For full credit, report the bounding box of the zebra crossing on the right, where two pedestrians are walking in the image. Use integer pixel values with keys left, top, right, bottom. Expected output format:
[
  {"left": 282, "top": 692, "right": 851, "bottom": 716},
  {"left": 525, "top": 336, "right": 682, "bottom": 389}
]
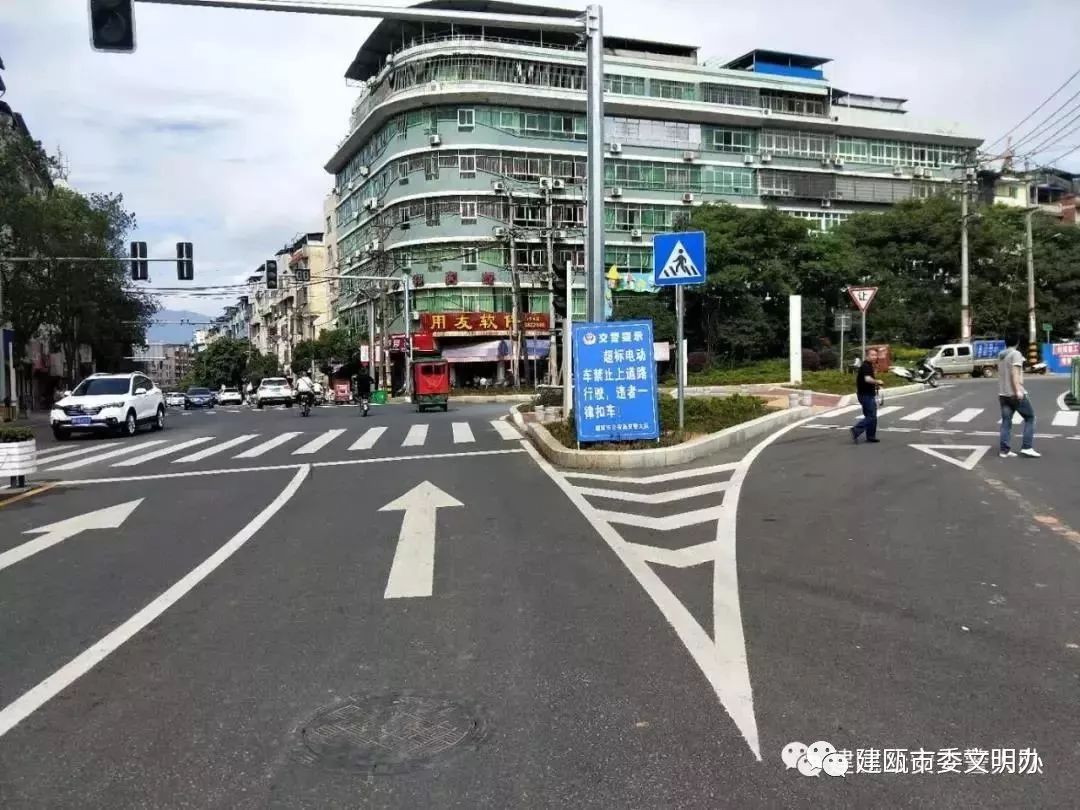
[{"left": 802, "top": 405, "right": 1080, "bottom": 442}]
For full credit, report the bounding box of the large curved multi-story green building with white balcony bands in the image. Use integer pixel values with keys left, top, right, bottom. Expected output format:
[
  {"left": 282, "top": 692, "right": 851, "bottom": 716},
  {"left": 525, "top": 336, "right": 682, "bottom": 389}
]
[{"left": 326, "top": 0, "right": 981, "bottom": 386}]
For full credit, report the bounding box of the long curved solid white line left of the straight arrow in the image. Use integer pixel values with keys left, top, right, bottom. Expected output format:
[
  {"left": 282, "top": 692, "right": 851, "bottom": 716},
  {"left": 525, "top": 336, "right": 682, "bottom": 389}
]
[{"left": 0, "top": 465, "right": 311, "bottom": 737}]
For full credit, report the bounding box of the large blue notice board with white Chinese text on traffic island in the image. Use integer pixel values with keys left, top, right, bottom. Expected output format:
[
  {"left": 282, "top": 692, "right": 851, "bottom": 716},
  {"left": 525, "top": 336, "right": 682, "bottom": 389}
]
[{"left": 573, "top": 321, "right": 660, "bottom": 442}]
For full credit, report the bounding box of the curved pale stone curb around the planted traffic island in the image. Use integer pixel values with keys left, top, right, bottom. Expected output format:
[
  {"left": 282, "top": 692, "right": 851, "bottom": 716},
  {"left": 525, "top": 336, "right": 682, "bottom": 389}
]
[{"left": 511, "top": 406, "right": 813, "bottom": 470}]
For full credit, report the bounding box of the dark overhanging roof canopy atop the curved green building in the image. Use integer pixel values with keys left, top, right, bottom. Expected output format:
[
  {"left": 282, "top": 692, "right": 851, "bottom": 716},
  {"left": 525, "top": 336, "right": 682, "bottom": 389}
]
[{"left": 345, "top": 0, "right": 698, "bottom": 81}]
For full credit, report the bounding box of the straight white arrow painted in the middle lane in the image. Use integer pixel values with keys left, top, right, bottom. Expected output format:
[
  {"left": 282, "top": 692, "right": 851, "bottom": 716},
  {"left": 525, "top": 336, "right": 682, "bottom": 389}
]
[{"left": 379, "top": 481, "right": 463, "bottom": 599}]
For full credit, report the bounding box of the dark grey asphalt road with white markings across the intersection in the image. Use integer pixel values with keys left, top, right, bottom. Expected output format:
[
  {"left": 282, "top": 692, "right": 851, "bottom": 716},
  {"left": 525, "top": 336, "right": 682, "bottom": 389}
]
[{"left": 0, "top": 380, "right": 1080, "bottom": 809}]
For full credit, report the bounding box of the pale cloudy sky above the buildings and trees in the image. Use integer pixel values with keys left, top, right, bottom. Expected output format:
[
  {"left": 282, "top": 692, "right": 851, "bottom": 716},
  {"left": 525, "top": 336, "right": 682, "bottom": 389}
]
[{"left": 0, "top": 0, "right": 1080, "bottom": 315}]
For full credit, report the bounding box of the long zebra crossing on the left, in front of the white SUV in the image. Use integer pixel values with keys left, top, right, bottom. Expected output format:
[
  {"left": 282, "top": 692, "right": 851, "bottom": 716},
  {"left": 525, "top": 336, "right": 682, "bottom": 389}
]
[{"left": 38, "top": 419, "right": 523, "bottom": 473}]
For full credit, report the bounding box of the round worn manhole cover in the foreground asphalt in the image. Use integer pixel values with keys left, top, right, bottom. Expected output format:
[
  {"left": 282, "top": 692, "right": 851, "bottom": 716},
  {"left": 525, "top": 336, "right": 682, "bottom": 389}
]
[{"left": 300, "top": 693, "right": 486, "bottom": 773}]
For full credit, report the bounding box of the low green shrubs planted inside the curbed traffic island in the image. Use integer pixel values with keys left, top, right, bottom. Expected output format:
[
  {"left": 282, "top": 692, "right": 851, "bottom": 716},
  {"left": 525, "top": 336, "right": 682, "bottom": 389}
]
[{"left": 543, "top": 394, "right": 773, "bottom": 450}]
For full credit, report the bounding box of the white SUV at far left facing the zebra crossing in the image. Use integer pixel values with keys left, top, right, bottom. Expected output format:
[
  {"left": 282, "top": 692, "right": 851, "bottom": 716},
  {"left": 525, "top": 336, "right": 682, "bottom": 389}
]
[{"left": 50, "top": 374, "right": 165, "bottom": 440}]
